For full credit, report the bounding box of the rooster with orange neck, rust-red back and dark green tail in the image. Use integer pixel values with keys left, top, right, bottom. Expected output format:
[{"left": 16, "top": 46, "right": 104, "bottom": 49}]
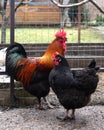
[{"left": 6, "top": 29, "right": 67, "bottom": 109}]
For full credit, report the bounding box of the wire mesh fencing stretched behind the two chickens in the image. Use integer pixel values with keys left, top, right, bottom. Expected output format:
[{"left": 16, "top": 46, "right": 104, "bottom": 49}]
[{"left": 0, "top": 0, "right": 104, "bottom": 105}]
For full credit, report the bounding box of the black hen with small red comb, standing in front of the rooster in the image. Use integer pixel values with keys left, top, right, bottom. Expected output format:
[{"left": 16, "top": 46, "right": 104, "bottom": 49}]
[{"left": 49, "top": 53, "right": 99, "bottom": 120}]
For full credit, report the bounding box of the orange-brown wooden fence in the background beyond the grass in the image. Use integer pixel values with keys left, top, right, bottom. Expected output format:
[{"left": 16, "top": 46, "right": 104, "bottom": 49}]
[{"left": 0, "top": 5, "right": 61, "bottom": 26}]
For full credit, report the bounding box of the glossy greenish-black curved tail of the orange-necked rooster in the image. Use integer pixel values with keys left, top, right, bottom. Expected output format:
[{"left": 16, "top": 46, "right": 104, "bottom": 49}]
[{"left": 5, "top": 43, "right": 27, "bottom": 79}]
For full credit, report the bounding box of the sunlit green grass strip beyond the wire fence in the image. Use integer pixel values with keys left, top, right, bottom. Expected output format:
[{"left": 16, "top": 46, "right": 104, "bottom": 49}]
[{"left": 0, "top": 27, "right": 104, "bottom": 43}]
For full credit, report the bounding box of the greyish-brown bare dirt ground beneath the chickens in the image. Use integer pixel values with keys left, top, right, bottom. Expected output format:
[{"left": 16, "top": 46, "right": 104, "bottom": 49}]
[{"left": 0, "top": 73, "right": 104, "bottom": 130}]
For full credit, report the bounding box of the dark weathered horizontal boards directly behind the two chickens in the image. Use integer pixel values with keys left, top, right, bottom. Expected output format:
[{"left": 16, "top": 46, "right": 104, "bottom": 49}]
[{"left": 0, "top": 43, "right": 104, "bottom": 68}]
